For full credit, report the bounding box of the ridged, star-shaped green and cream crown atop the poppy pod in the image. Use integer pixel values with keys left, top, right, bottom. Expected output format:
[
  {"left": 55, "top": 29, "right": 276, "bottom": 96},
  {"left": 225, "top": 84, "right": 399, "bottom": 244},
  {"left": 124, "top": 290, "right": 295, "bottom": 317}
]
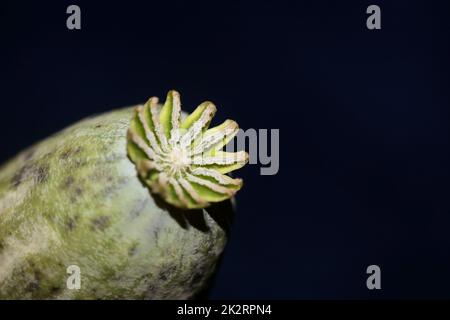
[{"left": 127, "top": 90, "right": 248, "bottom": 209}]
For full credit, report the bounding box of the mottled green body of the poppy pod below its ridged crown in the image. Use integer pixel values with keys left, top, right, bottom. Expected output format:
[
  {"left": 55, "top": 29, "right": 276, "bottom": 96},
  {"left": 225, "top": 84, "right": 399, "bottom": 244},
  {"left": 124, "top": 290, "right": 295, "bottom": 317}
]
[{"left": 0, "top": 107, "right": 233, "bottom": 299}]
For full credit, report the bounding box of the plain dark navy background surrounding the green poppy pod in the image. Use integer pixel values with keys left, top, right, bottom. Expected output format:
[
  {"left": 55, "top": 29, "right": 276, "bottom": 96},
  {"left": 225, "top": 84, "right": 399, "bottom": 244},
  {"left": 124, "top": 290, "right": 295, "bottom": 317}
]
[{"left": 0, "top": 0, "right": 450, "bottom": 298}]
